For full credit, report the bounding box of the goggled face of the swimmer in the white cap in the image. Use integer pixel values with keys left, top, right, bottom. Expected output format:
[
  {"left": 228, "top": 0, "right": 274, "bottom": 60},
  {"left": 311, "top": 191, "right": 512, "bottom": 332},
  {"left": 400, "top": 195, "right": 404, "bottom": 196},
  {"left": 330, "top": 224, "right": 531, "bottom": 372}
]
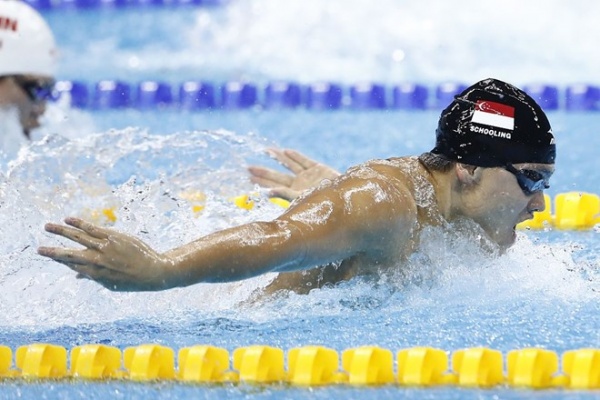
[{"left": 0, "top": 75, "right": 54, "bottom": 137}]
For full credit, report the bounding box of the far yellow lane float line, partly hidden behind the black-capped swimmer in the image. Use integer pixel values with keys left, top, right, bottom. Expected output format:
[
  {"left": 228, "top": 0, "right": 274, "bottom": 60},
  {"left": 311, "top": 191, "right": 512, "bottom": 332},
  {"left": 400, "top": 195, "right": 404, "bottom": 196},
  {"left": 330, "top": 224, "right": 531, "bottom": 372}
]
[{"left": 84, "top": 192, "right": 600, "bottom": 230}]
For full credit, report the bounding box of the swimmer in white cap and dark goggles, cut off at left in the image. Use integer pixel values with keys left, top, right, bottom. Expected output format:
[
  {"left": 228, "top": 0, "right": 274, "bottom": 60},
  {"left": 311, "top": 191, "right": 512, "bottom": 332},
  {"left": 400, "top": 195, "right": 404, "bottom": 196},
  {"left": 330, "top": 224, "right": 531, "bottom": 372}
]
[{"left": 0, "top": 0, "right": 57, "bottom": 139}]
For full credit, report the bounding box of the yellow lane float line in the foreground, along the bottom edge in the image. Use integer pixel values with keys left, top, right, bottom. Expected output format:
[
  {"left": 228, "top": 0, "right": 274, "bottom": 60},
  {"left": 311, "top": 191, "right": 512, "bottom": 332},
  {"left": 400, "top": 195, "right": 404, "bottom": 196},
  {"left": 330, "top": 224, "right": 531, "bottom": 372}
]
[{"left": 0, "top": 343, "right": 600, "bottom": 390}]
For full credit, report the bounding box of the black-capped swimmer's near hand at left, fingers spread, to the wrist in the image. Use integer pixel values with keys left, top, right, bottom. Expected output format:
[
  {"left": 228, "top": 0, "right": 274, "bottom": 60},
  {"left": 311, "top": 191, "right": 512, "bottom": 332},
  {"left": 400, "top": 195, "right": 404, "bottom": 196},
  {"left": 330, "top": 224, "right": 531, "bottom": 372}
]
[{"left": 38, "top": 218, "right": 173, "bottom": 291}]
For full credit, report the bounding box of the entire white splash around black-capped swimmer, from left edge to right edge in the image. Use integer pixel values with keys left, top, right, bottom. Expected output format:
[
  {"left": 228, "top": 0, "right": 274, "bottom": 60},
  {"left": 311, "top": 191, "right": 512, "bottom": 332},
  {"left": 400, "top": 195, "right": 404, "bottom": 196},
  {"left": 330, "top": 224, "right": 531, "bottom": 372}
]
[{"left": 0, "top": 128, "right": 599, "bottom": 329}]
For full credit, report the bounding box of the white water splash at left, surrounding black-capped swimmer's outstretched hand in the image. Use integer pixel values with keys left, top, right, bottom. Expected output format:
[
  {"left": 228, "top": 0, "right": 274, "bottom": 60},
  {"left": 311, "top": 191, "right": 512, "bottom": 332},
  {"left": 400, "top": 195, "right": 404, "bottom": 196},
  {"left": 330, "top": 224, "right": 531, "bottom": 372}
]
[{"left": 0, "top": 128, "right": 281, "bottom": 325}]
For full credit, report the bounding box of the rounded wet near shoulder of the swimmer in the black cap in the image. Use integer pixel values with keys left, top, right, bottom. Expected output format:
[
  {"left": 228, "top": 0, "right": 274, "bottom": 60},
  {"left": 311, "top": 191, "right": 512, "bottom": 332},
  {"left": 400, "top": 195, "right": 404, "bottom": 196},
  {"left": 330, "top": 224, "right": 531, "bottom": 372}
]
[{"left": 280, "top": 155, "right": 417, "bottom": 247}]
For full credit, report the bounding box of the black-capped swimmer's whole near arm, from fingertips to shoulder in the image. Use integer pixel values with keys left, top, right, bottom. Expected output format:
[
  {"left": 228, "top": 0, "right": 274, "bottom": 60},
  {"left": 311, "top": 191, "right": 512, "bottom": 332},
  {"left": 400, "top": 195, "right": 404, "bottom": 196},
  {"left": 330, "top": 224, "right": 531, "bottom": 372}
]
[{"left": 38, "top": 173, "right": 416, "bottom": 291}]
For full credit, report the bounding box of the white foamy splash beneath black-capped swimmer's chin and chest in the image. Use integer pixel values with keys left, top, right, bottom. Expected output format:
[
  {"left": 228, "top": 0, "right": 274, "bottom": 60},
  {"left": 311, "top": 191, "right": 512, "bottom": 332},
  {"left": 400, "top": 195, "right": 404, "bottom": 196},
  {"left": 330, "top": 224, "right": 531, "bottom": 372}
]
[{"left": 244, "top": 225, "right": 600, "bottom": 324}]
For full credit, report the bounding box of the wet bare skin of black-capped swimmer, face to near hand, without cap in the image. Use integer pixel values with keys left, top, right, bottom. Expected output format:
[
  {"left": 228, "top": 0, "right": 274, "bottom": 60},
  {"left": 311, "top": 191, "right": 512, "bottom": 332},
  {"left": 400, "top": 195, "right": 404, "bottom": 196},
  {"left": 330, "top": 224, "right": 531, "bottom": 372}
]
[{"left": 38, "top": 157, "right": 553, "bottom": 291}]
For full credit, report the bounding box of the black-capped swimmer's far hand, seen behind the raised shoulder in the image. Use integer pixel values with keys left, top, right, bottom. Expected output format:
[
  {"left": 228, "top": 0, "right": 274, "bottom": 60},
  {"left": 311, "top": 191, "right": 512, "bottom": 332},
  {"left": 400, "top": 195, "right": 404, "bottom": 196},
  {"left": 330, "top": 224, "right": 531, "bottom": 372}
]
[{"left": 248, "top": 149, "right": 340, "bottom": 200}]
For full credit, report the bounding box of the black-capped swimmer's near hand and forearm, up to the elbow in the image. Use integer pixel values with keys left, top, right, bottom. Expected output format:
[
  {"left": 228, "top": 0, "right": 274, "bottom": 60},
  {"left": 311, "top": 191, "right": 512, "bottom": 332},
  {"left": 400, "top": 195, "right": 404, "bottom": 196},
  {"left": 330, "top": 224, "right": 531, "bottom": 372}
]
[{"left": 38, "top": 218, "right": 310, "bottom": 291}]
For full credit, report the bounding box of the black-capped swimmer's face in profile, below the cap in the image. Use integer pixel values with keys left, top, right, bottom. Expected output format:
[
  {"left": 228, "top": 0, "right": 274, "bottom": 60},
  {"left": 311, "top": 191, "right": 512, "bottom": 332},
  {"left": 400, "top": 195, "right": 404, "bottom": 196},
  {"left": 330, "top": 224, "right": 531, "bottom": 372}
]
[{"left": 465, "top": 164, "right": 554, "bottom": 248}]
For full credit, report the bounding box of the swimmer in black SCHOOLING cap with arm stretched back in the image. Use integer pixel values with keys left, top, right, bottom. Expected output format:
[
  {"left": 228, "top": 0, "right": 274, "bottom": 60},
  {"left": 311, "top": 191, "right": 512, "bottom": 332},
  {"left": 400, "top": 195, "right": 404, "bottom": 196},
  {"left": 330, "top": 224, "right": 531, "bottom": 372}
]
[{"left": 38, "top": 79, "right": 556, "bottom": 293}]
